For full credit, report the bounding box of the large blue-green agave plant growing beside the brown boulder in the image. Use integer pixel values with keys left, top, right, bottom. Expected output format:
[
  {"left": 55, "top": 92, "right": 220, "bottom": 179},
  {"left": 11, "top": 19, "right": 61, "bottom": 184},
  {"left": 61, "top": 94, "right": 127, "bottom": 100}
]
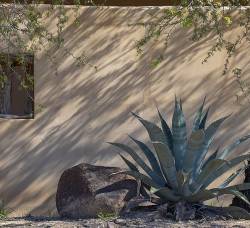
[{"left": 111, "top": 99, "right": 250, "bottom": 220}]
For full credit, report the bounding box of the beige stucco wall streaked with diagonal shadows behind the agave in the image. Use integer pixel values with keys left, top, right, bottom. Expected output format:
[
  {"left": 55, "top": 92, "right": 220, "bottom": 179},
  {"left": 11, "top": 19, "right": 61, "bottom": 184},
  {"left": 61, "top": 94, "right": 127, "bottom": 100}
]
[{"left": 0, "top": 7, "right": 250, "bottom": 215}]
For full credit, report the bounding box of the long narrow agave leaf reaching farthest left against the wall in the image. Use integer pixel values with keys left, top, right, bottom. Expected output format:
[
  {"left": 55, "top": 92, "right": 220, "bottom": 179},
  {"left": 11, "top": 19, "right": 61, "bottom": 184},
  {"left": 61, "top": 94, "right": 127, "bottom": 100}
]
[{"left": 110, "top": 143, "right": 165, "bottom": 184}]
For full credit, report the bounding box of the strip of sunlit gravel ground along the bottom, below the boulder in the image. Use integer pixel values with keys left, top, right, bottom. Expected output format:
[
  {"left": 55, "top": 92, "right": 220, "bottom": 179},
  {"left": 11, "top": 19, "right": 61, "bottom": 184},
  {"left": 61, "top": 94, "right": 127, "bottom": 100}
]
[{"left": 0, "top": 213, "right": 250, "bottom": 228}]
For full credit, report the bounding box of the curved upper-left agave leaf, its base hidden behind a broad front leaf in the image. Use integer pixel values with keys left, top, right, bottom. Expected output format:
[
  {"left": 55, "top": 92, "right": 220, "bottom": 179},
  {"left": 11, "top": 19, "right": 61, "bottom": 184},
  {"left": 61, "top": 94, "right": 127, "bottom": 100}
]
[{"left": 132, "top": 112, "right": 167, "bottom": 144}]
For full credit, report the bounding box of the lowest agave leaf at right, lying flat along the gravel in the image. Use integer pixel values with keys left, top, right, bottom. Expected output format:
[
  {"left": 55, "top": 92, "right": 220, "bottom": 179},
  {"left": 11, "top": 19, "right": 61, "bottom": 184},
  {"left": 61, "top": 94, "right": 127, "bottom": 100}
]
[{"left": 212, "top": 206, "right": 250, "bottom": 220}]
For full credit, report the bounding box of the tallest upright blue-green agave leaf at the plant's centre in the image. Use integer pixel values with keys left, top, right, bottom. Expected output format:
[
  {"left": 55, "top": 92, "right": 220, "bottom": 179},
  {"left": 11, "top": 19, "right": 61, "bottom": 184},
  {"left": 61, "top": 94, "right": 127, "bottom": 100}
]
[{"left": 172, "top": 99, "right": 187, "bottom": 171}]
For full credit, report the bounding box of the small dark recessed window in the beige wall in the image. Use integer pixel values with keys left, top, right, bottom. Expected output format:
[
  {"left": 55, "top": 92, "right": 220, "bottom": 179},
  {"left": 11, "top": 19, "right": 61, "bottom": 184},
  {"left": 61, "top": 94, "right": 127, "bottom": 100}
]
[{"left": 0, "top": 54, "right": 34, "bottom": 119}]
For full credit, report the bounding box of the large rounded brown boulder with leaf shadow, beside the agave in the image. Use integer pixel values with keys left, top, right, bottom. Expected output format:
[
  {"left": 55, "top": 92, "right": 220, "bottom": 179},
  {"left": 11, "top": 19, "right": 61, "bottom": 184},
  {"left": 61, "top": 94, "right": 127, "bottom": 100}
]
[{"left": 56, "top": 163, "right": 137, "bottom": 218}]
